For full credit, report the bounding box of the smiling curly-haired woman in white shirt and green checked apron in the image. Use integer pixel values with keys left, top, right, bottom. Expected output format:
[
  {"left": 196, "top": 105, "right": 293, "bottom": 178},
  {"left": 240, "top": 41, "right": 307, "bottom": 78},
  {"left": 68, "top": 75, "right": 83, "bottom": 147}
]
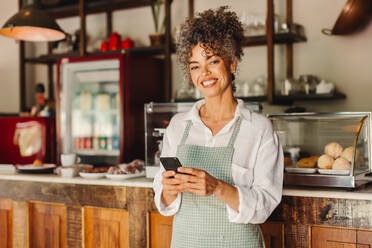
[{"left": 154, "top": 7, "right": 283, "bottom": 248}]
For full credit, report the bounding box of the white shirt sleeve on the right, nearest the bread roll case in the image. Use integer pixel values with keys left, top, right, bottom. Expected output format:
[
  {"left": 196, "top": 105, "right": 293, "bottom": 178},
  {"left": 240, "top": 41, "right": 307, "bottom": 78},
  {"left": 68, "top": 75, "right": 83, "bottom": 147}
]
[{"left": 226, "top": 125, "right": 283, "bottom": 224}]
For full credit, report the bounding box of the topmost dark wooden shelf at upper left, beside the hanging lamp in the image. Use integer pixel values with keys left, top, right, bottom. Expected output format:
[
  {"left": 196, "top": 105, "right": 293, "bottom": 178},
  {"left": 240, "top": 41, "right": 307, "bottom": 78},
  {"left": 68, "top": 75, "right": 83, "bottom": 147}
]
[{"left": 43, "top": 0, "right": 150, "bottom": 18}]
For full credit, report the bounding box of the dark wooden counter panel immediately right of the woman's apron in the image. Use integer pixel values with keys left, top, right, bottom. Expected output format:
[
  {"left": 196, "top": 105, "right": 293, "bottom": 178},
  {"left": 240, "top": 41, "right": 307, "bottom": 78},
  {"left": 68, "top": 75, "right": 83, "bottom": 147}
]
[{"left": 260, "top": 222, "right": 284, "bottom": 248}]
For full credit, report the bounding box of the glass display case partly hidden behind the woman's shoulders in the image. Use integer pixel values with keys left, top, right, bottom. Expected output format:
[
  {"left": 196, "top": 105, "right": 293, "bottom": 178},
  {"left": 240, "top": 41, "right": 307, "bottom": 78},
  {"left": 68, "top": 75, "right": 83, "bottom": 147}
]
[{"left": 144, "top": 102, "right": 262, "bottom": 177}]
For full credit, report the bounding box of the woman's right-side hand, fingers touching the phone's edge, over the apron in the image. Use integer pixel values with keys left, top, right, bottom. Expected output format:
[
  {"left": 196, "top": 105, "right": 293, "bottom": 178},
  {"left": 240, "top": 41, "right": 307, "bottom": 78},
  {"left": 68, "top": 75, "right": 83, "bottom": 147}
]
[{"left": 174, "top": 167, "right": 221, "bottom": 196}]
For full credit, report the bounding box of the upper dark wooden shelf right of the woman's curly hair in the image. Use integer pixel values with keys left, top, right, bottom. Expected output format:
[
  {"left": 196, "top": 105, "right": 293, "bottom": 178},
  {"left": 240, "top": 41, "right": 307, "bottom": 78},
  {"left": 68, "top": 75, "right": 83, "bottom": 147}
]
[{"left": 243, "top": 33, "right": 307, "bottom": 46}]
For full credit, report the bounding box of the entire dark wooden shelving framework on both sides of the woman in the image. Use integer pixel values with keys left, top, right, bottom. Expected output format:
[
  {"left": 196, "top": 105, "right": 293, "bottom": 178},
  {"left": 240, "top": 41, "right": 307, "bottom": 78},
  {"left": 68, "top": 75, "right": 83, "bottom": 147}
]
[{"left": 19, "top": 0, "right": 346, "bottom": 110}]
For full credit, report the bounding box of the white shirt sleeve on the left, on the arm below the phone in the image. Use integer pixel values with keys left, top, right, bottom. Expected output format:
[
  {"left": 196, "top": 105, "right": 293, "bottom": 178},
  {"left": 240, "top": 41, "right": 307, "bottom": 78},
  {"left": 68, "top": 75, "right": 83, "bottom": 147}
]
[{"left": 153, "top": 122, "right": 181, "bottom": 216}]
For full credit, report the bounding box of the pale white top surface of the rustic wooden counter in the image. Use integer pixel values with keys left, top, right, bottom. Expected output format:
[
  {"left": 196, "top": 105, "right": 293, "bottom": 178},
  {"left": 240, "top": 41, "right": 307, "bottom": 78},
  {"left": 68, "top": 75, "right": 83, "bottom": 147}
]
[{"left": 0, "top": 174, "right": 372, "bottom": 200}]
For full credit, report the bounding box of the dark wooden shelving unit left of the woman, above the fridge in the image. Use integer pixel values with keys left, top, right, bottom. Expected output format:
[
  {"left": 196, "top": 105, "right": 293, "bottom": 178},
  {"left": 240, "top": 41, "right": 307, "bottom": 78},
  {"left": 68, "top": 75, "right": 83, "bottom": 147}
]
[{"left": 19, "top": 0, "right": 172, "bottom": 111}]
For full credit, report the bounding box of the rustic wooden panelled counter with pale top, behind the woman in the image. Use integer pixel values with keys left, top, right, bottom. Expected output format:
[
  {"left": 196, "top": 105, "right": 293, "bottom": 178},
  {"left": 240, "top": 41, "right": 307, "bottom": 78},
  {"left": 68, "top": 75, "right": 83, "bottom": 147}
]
[{"left": 0, "top": 174, "right": 372, "bottom": 248}]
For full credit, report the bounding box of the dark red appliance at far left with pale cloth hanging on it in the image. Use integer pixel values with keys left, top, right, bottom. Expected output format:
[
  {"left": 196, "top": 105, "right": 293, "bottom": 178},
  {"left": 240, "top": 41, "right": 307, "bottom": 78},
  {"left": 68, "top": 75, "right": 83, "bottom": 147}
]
[{"left": 0, "top": 116, "right": 56, "bottom": 165}]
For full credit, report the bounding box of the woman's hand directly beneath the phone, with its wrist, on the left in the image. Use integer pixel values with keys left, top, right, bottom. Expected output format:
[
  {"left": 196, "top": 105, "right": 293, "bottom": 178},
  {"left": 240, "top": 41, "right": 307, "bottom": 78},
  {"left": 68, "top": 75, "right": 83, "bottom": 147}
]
[{"left": 161, "top": 171, "right": 181, "bottom": 206}]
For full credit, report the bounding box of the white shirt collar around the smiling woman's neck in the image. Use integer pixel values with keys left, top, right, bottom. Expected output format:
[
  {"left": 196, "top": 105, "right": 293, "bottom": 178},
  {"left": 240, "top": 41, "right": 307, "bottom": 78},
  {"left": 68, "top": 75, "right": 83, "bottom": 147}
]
[{"left": 185, "top": 99, "right": 251, "bottom": 123}]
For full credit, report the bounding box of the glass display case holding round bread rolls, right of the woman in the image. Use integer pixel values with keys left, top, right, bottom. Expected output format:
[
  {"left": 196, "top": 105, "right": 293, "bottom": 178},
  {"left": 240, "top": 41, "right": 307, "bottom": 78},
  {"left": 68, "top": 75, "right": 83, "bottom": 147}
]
[{"left": 269, "top": 112, "right": 372, "bottom": 188}]
